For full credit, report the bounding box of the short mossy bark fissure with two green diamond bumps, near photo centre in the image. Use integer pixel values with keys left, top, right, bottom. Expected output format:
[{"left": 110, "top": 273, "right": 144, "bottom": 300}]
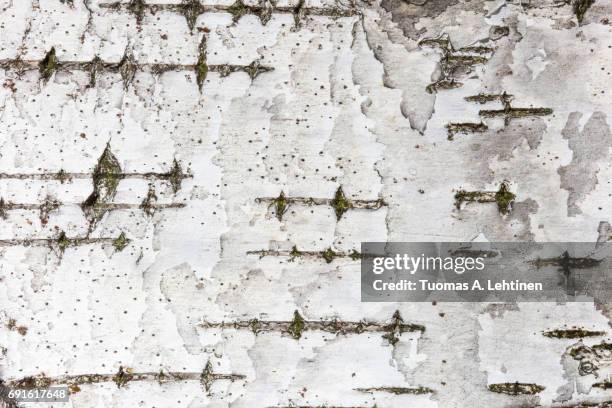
[{"left": 255, "top": 187, "right": 387, "bottom": 221}]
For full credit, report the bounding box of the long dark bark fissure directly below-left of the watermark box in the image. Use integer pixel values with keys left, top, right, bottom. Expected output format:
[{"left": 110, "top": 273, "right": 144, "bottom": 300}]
[{"left": 199, "top": 310, "right": 425, "bottom": 345}]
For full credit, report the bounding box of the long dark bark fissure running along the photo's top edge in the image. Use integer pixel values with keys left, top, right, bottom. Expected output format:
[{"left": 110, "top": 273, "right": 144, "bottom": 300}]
[{"left": 100, "top": 0, "right": 358, "bottom": 31}]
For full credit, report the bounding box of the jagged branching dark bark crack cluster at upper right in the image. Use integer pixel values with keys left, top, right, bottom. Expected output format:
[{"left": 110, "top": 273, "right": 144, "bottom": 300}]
[{"left": 419, "top": 35, "right": 494, "bottom": 93}]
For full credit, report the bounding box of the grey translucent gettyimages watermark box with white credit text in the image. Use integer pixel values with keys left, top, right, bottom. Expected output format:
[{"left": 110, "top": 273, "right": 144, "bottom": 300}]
[{"left": 361, "top": 242, "right": 612, "bottom": 302}]
